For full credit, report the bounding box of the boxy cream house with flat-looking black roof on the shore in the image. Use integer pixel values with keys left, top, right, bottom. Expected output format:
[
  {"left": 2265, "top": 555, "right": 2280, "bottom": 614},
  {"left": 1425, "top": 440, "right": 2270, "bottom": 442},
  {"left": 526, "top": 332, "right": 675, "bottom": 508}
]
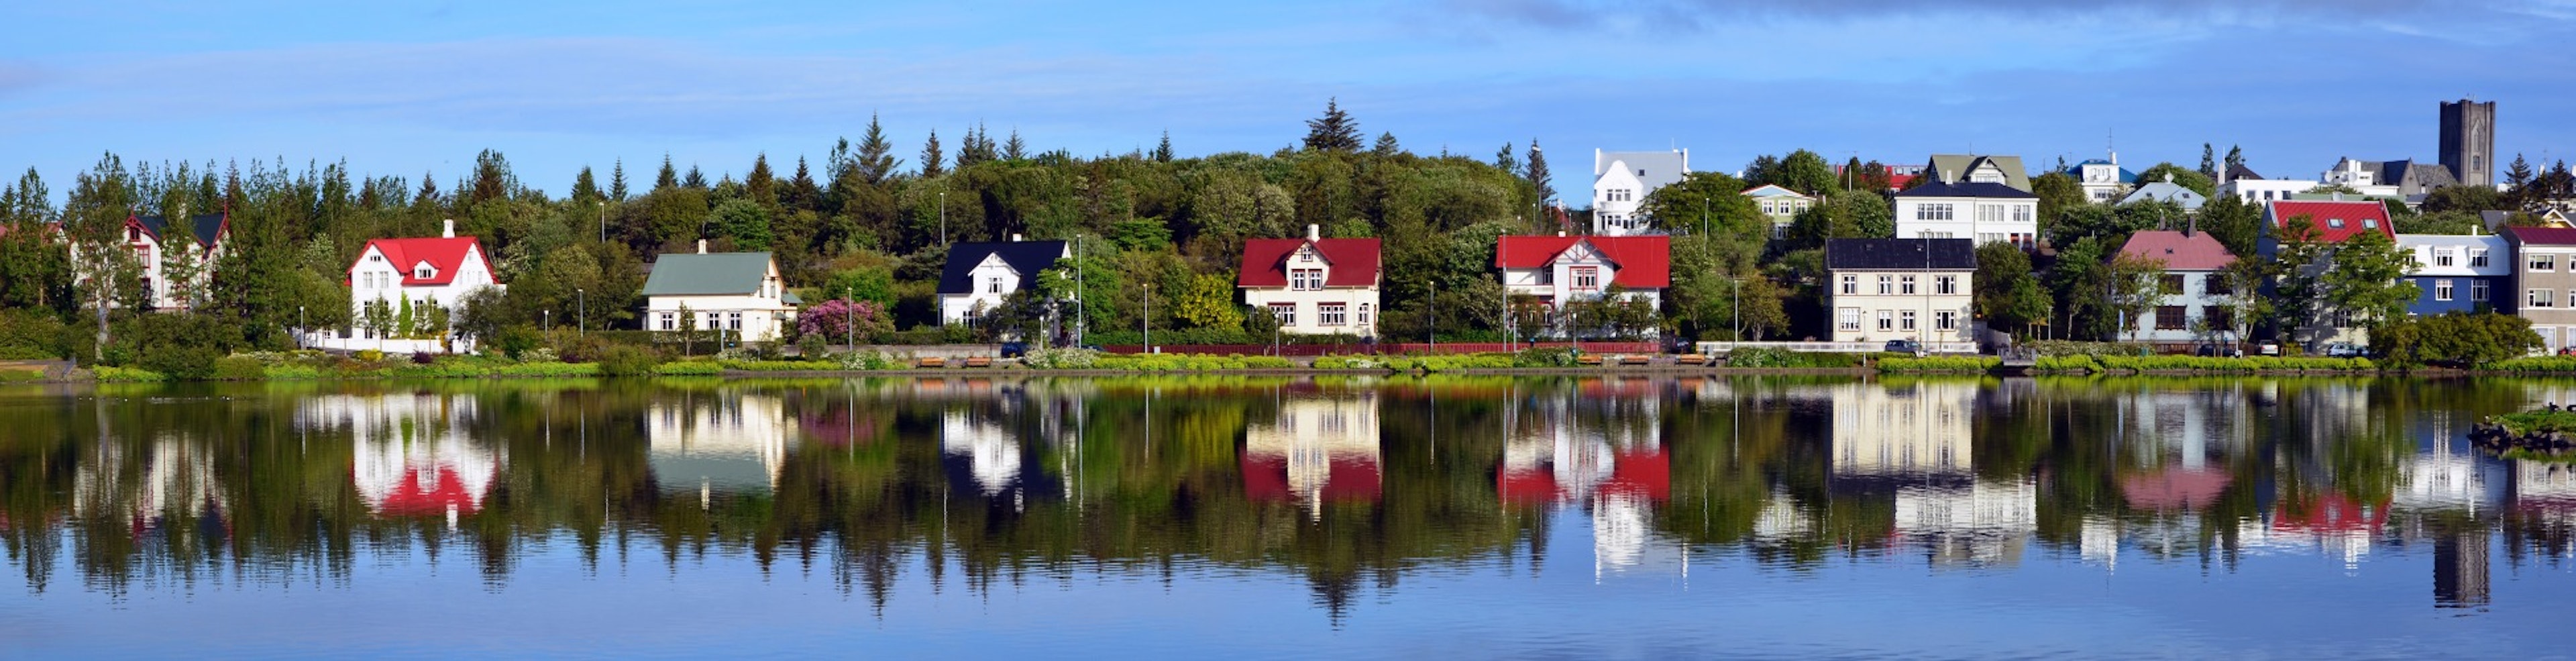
[{"left": 1824, "top": 239, "right": 1976, "bottom": 350}]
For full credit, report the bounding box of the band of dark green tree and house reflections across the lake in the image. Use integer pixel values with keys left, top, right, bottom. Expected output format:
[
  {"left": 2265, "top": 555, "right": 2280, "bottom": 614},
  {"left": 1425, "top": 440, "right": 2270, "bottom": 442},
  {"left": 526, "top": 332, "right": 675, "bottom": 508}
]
[{"left": 0, "top": 376, "right": 2576, "bottom": 617}]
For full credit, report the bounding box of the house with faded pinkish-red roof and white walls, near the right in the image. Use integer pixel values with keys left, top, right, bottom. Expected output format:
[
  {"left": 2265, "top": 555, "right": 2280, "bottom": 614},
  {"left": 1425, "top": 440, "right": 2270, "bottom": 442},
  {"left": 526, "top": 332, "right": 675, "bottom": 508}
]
[{"left": 2120, "top": 229, "right": 2236, "bottom": 345}]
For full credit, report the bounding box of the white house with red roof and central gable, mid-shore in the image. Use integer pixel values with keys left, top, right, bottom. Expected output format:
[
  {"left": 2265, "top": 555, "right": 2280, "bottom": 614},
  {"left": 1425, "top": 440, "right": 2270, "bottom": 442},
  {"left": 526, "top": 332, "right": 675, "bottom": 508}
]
[{"left": 1234, "top": 223, "right": 1386, "bottom": 337}]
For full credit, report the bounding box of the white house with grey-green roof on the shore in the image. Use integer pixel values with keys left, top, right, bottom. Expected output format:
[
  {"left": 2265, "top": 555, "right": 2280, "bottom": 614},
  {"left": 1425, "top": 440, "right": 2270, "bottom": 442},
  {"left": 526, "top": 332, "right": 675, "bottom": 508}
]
[{"left": 644, "top": 242, "right": 804, "bottom": 342}]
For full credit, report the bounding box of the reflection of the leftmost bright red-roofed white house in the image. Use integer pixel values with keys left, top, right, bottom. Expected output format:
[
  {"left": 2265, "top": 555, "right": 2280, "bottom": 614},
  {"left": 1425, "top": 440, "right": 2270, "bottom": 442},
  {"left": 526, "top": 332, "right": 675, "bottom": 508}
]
[{"left": 297, "top": 393, "right": 505, "bottom": 527}]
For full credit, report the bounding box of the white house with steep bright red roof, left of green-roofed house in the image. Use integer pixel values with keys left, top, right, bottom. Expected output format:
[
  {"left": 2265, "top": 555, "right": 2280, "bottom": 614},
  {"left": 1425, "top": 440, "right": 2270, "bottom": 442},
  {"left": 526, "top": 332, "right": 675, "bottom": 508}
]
[{"left": 325, "top": 221, "right": 500, "bottom": 352}]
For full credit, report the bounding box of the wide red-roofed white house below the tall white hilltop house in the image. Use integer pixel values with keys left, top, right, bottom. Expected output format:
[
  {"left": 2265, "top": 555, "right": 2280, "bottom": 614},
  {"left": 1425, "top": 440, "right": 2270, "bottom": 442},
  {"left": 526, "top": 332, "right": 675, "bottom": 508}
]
[{"left": 1494, "top": 234, "right": 1672, "bottom": 319}]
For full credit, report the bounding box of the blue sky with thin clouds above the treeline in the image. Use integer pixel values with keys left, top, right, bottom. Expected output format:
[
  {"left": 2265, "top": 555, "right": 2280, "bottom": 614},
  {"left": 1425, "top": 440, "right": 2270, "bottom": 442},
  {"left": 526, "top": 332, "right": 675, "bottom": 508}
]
[{"left": 0, "top": 0, "right": 2576, "bottom": 206}]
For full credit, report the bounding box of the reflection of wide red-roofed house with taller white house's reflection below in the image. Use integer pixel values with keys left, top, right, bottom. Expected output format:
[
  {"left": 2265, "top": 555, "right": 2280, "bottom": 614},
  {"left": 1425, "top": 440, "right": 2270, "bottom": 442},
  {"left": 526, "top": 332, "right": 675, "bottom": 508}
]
[{"left": 1494, "top": 378, "right": 1687, "bottom": 576}]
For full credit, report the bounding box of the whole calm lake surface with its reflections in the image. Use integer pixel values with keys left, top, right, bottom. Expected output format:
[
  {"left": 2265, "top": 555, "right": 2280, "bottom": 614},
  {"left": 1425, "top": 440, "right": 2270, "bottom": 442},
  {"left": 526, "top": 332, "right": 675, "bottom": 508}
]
[{"left": 0, "top": 378, "right": 2576, "bottom": 658}]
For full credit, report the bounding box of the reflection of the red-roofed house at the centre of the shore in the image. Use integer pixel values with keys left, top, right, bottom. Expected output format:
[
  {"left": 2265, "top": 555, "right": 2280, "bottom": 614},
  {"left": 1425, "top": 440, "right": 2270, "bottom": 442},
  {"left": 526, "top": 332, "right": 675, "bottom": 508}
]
[{"left": 1239, "top": 391, "right": 1383, "bottom": 519}]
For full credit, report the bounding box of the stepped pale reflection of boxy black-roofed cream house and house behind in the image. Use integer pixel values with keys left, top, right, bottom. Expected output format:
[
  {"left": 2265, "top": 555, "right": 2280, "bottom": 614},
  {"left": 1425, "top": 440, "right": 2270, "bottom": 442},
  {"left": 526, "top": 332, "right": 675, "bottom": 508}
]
[{"left": 1831, "top": 380, "right": 2037, "bottom": 566}]
